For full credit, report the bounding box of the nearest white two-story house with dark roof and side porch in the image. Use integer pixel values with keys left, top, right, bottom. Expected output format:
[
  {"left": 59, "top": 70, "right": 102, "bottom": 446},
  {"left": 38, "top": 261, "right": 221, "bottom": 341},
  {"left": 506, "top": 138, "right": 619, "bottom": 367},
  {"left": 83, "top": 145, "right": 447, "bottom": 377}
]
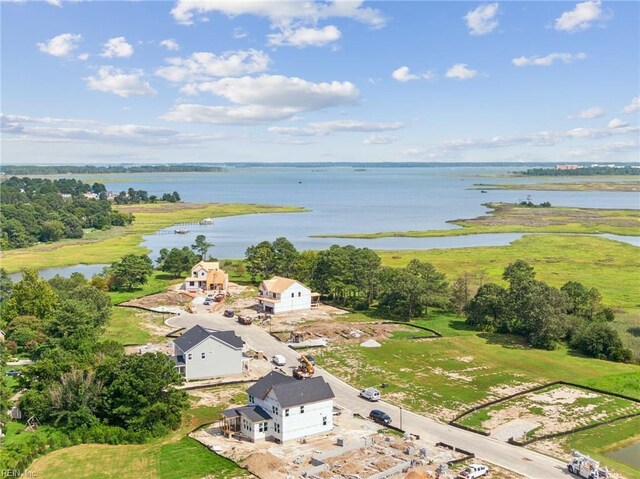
[{"left": 221, "top": 371, "right": 334, "bottom": 442}]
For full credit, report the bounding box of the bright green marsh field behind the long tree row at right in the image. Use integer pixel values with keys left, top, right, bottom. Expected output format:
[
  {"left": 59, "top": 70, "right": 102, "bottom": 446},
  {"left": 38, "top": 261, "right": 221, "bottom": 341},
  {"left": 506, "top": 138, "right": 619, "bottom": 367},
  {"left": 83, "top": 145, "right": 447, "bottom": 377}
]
[{"left": 377, "top": 235, "right": 640, "bottom": 310}]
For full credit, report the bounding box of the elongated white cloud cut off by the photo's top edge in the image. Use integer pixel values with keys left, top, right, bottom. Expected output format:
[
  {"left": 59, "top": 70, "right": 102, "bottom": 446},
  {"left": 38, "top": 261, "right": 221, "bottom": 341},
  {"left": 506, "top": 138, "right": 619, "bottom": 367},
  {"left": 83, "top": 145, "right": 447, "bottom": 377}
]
[{"left": 171, "top": 0, "right": 386, "bottom": 28}]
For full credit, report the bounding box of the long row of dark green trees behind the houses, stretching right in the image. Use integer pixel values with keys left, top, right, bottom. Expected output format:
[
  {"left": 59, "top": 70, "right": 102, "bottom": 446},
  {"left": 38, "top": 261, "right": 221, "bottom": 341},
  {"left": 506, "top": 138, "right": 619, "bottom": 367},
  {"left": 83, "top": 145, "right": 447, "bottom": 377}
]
[{"left": 245, "top": 238, "right": 633, "bottom": 362}]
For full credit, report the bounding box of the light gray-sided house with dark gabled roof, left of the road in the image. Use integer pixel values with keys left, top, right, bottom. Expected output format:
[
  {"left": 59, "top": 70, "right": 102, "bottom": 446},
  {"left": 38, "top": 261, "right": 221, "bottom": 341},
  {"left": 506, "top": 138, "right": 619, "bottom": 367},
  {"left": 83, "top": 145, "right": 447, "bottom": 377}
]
[{"left": 173, "top": 325, "right": 244, "bottom": 381}]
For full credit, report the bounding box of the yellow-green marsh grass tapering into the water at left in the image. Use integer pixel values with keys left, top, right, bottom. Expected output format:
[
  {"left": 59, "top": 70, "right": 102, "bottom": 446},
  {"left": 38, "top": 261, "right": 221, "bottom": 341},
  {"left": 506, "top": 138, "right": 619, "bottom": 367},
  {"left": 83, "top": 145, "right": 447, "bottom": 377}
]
[{"left": 0, "top": 203, "right": 306, "bottom": 273}]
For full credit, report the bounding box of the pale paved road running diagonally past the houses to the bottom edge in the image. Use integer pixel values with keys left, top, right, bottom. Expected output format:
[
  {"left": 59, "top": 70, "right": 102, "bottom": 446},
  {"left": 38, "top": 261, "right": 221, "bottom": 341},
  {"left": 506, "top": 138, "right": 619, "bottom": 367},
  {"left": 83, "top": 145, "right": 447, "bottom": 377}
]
[{"left": 167, "top": 312, "right": 572, "bottom": 479}]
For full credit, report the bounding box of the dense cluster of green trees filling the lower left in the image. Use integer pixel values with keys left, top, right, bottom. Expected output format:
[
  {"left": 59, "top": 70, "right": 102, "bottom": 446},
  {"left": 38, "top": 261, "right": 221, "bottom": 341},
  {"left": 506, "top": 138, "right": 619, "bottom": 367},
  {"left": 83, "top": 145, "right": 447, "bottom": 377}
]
[{"left": 0, "top": 270, "right": 188, "bottom": 469}]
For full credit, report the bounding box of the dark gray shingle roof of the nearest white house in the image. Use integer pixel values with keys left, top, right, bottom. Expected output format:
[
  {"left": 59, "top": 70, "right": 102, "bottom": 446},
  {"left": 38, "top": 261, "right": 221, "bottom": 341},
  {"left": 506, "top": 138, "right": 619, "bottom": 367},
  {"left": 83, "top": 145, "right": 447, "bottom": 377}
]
[{"left": 247, "top": 372, "right": 335, "bottom": 408}]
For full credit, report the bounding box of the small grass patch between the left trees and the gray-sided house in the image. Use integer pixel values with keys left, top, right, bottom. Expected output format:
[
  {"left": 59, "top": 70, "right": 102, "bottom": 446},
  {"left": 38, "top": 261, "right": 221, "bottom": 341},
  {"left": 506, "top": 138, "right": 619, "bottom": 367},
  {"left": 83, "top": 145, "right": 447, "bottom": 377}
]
[{"left": 102, "top": 308, "right": 167, "bottom": 344}]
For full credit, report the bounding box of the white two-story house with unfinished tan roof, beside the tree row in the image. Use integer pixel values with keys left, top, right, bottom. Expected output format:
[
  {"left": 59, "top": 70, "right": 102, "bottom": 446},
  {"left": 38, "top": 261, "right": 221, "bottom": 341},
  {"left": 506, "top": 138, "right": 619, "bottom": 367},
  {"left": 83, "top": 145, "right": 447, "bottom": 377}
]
[{"left": 257, "top": 276, "right": 312, "bottom": 314}]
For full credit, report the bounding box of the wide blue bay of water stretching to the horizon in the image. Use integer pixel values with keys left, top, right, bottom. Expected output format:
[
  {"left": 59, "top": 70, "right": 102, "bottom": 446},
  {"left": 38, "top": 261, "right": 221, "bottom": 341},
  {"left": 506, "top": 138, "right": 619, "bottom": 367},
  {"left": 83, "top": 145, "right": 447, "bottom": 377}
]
[{"left": 17, "top": 165, "right": 640, "bottom": 275}]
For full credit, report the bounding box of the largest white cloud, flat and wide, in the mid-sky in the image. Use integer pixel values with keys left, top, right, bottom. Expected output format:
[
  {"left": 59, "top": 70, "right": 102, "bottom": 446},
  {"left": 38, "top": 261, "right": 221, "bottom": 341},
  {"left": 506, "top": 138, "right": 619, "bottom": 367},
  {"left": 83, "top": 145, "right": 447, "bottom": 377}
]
[{"left": 162, "top": 75, "right": 360, "bottom": 124}]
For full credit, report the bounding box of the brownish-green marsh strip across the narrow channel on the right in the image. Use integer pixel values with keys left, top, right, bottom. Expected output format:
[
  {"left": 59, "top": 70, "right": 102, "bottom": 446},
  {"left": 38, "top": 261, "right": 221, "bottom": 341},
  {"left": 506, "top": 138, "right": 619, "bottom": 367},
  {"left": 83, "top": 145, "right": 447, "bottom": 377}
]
[{"left": 316, "top": 203, "right": 640, "bottom": 239}]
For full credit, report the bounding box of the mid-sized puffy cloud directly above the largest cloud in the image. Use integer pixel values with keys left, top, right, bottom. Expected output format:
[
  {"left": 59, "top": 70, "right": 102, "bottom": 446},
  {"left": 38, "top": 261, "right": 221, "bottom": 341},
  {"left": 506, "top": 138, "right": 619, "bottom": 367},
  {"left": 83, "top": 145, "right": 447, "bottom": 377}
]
[{"left": 156, "top": 49, "right": 271, "bottom": 82}]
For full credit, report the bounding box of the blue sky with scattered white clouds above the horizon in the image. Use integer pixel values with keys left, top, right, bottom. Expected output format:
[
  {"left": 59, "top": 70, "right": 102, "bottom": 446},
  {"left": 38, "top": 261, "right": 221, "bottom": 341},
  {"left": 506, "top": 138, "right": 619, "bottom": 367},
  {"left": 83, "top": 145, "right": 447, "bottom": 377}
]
[{"left": 0, "top": 0, "right": 640, "bottom": 164}]
